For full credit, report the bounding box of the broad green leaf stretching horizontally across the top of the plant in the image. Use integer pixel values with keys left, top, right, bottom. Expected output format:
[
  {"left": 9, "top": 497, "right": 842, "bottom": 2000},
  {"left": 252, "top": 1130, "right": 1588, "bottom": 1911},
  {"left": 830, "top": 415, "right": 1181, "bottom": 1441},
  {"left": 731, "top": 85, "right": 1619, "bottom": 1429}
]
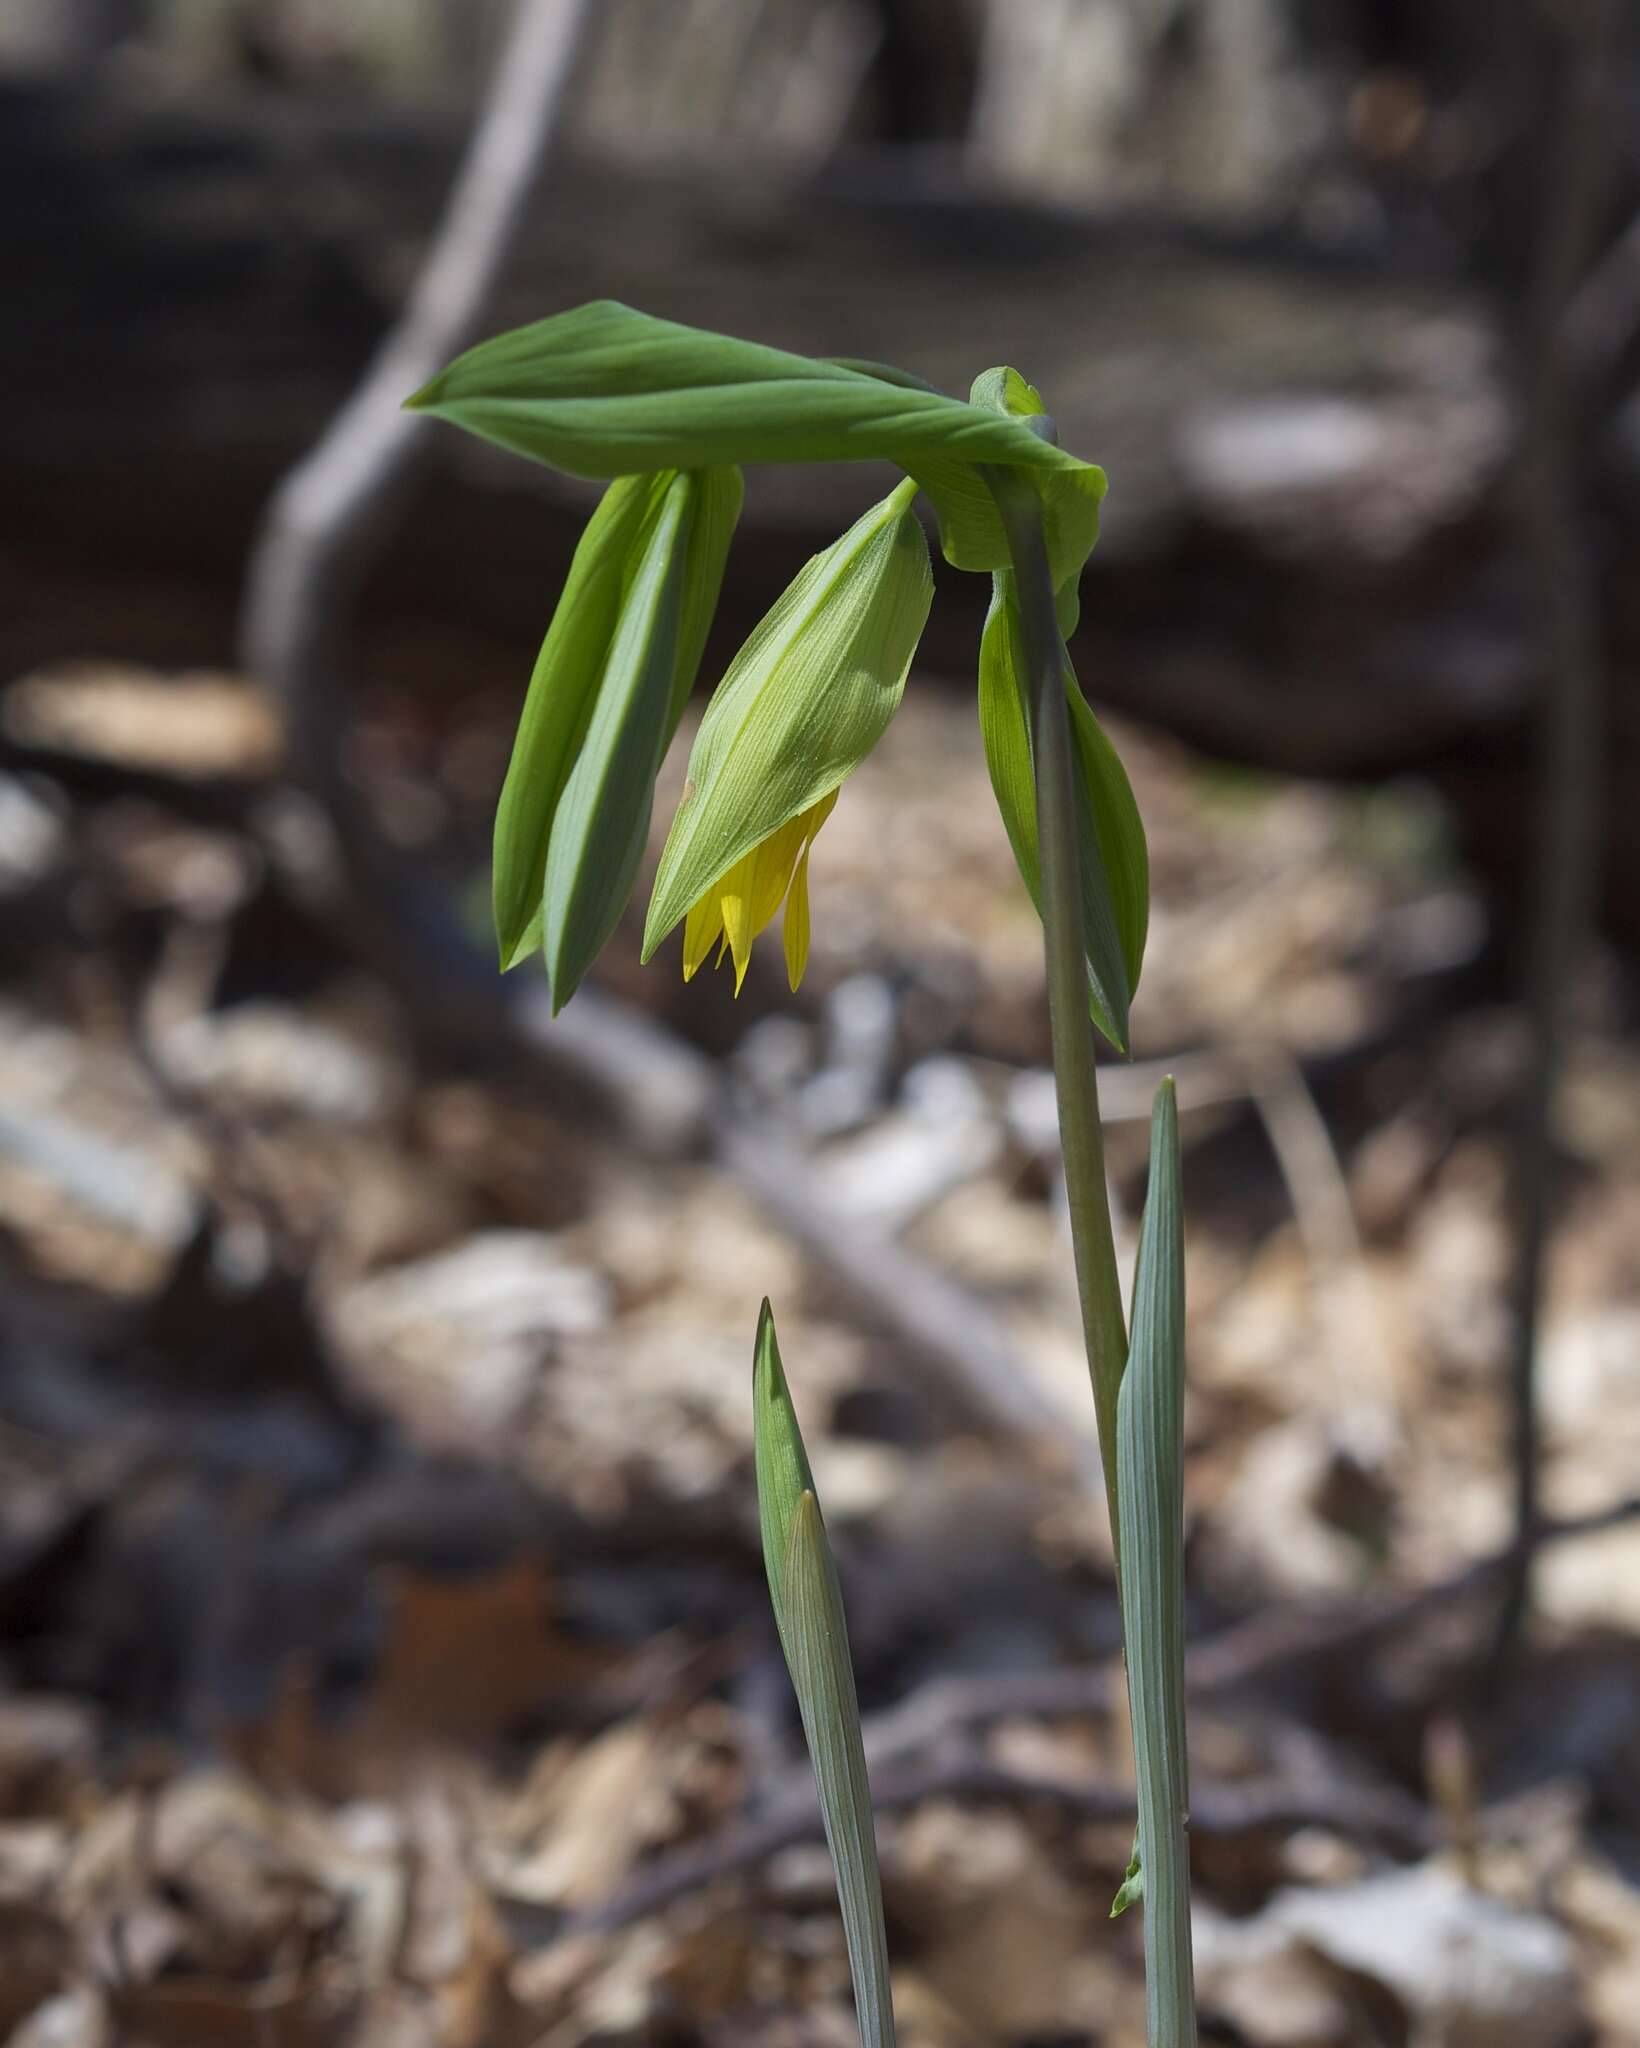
[{"left": 407, "top": 299, "right": 1106, "bottom": 584}]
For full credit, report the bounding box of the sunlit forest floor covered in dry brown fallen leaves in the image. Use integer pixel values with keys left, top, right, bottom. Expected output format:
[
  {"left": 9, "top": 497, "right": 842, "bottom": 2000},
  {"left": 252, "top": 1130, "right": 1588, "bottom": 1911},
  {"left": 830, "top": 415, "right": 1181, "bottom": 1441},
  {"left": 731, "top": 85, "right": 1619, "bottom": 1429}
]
[{"left": 0, "top": 643, "right": 1640, "bottom": 2048}]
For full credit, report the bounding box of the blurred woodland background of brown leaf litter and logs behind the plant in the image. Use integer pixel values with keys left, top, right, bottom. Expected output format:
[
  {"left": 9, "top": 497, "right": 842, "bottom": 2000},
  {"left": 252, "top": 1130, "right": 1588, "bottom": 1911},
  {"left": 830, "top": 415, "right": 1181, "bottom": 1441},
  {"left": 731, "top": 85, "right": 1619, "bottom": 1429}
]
[{"left": 0, "top": 0, "right": 1640, "bottom": 2048}]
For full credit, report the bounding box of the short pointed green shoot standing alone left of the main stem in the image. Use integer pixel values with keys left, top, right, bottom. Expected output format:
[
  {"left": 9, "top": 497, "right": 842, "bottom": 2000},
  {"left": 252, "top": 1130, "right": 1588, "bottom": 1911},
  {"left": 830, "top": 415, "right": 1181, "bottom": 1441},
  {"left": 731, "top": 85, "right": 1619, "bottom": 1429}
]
[{"left": 751, "top": 1303, "right": 895, "bottom": 2048}]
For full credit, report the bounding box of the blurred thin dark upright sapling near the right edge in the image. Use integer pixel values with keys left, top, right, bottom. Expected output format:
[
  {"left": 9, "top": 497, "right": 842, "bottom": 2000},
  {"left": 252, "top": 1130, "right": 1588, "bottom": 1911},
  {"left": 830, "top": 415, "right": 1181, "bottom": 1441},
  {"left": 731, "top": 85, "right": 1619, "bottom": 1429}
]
[{"left": 1491, "top": 0, "right": 1617, "bottom": 1673}]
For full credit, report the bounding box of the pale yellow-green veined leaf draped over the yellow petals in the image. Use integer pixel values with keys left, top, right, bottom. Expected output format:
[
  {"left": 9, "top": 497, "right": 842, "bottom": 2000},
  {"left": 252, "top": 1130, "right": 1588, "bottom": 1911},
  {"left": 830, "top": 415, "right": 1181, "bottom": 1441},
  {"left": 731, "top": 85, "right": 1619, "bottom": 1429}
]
[{"left": 643, "top": 483, "right": 934, "bottom": 961}]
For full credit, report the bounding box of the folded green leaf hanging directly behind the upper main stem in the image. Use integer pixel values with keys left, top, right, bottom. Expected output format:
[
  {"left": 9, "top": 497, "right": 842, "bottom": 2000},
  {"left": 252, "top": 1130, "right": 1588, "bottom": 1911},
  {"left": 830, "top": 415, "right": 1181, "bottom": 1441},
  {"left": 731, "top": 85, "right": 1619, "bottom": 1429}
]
[{"left": 979, "top": 569, "right": 1151, "bottom": 1053}]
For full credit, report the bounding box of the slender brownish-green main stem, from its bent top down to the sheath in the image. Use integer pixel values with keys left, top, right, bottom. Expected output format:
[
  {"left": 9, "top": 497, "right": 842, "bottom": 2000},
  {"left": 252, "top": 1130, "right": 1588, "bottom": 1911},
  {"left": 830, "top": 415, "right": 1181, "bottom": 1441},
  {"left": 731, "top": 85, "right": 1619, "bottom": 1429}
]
[{"left": 987, "top": 469, "right": 1128, "bottom": 1559}]
